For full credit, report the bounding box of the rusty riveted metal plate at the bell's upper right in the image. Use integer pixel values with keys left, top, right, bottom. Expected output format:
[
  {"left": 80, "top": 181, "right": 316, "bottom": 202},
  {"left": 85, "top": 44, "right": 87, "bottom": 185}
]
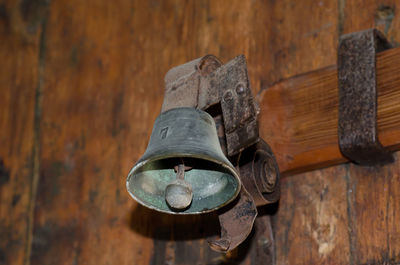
[{"left": 202, "top": 55, "right": 259, "bottom": 156}]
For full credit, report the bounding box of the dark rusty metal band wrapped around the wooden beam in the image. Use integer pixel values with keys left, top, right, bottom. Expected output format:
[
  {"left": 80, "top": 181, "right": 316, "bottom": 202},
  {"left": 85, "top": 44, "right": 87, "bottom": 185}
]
[{"left": 338, "top": 29, "right": 393, "bottom": 165}]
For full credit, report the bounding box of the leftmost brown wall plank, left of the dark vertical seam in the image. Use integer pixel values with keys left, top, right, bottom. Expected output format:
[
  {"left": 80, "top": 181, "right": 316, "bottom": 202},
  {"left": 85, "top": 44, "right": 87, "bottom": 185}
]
[{"left": 0, "top": 1, "right": 45, "bottom": 265}]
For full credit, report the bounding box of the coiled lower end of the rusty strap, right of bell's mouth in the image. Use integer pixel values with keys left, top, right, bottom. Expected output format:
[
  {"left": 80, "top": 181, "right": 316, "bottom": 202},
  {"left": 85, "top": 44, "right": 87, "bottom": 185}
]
[{"left": 209, "top": 139, "right": 280, "bottom": 252}]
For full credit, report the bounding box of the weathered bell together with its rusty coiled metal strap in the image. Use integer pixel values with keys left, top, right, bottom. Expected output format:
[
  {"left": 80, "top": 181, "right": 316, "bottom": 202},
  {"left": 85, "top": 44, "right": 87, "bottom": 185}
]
[{"left": 127, "top": 55, "right": 280, "bottom": 260}]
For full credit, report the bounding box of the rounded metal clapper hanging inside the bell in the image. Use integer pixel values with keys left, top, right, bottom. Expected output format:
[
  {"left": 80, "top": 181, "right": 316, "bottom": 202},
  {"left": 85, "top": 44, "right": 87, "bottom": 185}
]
[{"left": 165, "top": 160, "right": 193, "bottom": 211}]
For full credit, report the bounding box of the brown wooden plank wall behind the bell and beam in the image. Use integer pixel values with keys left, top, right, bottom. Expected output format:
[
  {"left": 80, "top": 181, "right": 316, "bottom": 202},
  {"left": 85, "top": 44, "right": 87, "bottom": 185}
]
[{"left": 0, "top": 0, "right": 400, "bottom": 265}]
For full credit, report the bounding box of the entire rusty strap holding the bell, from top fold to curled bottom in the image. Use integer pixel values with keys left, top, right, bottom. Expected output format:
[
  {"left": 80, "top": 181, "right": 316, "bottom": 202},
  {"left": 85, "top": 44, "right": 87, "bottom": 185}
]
[{"left": 162, "top": 55, "right": 280, "bottom": 253}]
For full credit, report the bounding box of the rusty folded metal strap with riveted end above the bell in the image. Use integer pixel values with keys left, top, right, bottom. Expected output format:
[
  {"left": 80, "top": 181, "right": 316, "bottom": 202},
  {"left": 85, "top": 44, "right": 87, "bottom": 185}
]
[{"left": 161, "top": 55, "right": 258, "bottom": 156}]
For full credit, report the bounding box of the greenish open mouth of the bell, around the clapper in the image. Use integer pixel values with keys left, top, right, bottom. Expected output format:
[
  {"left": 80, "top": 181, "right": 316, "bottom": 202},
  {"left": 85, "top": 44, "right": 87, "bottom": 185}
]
[{"left": 126, "top": 154, "right": 241, "bottom": 214}]
